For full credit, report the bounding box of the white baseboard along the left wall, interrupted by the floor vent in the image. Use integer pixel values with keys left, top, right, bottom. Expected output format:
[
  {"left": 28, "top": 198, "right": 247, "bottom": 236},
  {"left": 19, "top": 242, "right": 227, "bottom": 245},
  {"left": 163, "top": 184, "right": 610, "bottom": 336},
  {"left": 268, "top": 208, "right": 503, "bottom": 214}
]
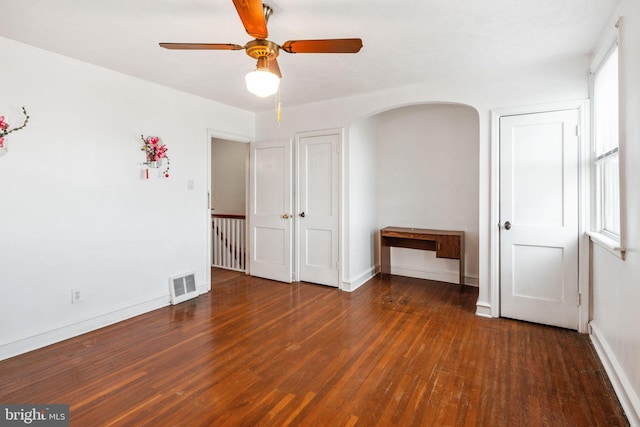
[{"left": 0, "top": 284, "right": 208, "bottom": 360}]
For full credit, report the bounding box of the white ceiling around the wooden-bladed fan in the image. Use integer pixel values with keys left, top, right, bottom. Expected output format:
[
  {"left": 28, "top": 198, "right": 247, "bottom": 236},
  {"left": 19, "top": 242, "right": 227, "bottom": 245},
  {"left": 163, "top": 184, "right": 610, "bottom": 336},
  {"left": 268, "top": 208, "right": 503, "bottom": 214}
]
[{"left": 0, "top": 0, "right": 619, "bottom": 111}]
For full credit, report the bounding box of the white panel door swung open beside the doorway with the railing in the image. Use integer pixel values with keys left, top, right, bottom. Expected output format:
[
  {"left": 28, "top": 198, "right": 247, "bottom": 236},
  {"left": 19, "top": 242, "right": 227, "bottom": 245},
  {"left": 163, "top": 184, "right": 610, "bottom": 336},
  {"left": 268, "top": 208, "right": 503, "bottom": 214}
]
[{"left": 249, "top": 140, "right": 293, "bottom": 283}]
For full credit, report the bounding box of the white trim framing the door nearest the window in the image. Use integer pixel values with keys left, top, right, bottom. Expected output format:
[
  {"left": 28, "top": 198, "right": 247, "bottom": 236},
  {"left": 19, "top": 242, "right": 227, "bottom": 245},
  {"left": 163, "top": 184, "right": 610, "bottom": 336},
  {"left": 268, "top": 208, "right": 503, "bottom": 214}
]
[{"left": 490, "top": 99, "right": 591, "bottom": 333}]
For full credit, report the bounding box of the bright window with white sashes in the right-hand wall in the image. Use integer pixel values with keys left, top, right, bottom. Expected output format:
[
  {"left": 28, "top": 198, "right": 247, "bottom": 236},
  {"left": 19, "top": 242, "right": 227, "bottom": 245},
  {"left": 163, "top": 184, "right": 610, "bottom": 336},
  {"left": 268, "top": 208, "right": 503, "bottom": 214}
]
[{"left": 593, "top": 44, "right": 620, "bottom": 242}]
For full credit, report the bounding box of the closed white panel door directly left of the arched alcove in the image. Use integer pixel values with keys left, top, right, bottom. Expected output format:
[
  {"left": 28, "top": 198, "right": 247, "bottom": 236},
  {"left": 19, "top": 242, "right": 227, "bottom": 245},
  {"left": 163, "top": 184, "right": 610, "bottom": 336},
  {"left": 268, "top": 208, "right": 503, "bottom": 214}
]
[{"left": 296, "top": 132, "right": 340, "bottom": 286}]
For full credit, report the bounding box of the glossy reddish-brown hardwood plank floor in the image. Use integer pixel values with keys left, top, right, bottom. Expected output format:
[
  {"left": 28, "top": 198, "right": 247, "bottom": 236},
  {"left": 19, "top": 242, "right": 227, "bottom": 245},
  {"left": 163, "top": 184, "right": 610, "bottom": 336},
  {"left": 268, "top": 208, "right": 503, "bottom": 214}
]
[{"left": 0, "top": 269, "right": 628, "bottom": 426}]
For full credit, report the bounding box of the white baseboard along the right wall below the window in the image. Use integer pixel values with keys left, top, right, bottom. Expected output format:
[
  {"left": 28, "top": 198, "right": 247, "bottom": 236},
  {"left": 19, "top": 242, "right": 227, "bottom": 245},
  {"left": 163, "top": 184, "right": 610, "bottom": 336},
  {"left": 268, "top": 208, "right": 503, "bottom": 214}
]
[{"left": 589, "top": 322, "right": 640, "bottom": 427}]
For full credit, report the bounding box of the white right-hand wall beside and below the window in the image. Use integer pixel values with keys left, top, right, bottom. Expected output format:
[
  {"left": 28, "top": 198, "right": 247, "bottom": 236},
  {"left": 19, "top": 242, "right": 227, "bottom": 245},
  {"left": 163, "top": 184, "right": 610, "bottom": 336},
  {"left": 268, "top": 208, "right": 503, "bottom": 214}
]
[{"left": 592, "top": 0, "right": 640, "bottom": 426}]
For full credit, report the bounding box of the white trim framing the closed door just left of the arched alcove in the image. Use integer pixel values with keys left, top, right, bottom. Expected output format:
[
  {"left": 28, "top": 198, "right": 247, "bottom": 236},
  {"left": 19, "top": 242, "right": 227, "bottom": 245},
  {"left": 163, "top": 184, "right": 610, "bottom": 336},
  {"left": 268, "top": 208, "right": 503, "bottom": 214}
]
[{"left": 293, "top": 128, "right": 344, "bottom": 290}]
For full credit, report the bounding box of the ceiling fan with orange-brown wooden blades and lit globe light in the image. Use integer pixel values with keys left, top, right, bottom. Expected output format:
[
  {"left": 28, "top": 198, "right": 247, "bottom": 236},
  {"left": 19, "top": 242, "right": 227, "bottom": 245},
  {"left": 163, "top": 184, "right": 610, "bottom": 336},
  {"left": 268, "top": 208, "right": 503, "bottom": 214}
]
[{"left": 160, "top": 0, "right": 362, "bottom": 97}]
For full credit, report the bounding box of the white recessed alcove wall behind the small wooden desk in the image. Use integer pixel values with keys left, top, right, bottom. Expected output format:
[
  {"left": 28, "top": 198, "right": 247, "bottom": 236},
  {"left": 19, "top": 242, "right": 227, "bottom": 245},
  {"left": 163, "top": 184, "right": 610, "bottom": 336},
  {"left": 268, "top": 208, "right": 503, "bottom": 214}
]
[{"left": 375, "top": 104, "right": 479, "bottom": 285}]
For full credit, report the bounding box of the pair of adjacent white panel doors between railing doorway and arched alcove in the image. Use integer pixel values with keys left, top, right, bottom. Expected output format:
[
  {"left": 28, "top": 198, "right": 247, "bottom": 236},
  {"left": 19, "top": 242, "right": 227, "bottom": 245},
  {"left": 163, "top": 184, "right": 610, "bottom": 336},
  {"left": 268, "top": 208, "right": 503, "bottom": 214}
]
[{"left": 249, "top": 130, "right": 342, "bottom": 287}]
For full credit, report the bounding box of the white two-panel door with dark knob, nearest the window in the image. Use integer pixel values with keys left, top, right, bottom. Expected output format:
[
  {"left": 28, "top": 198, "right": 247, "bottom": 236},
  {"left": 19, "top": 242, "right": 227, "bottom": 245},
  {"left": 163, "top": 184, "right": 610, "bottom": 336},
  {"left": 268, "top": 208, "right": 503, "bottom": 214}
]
[{"left": 500, "top": 110, "right": 579, "bottom": 329}]
